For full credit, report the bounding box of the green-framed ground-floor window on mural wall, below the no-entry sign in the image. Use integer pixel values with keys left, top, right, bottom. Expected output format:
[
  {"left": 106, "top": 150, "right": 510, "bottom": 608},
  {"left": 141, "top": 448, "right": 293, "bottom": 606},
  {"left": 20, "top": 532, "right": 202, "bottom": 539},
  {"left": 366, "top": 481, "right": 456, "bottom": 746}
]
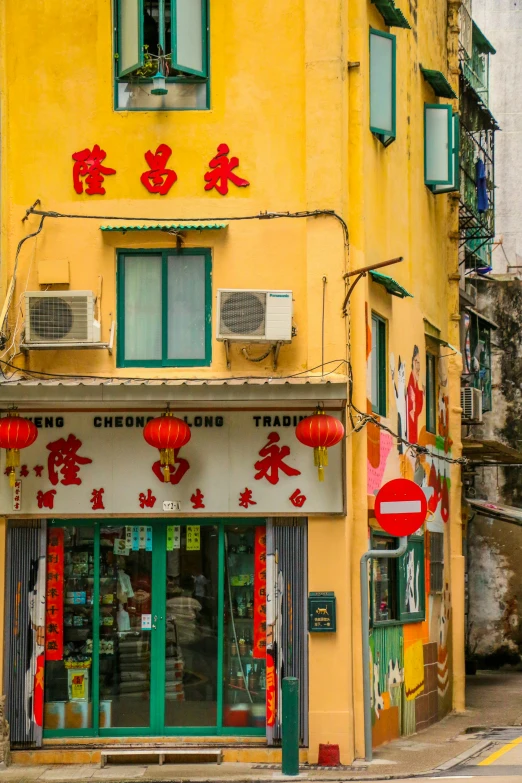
[{"left": 370, "top": 531, "right": 426, "bottom": 627}]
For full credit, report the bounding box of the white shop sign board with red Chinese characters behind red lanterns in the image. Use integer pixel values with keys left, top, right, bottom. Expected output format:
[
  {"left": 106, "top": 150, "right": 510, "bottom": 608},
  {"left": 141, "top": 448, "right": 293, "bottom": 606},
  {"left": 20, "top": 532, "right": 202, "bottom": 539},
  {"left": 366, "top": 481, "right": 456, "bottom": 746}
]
[{"left": 0, "top": 410, "right": 344, "bottom": 517}]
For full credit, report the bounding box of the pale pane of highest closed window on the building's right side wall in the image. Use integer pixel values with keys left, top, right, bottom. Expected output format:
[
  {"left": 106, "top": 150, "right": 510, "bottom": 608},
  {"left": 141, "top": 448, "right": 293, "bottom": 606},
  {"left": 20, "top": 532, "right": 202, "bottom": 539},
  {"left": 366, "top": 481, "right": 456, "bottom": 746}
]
[{"left": 370, "top": 35, "right": 394, "bottom": 134}]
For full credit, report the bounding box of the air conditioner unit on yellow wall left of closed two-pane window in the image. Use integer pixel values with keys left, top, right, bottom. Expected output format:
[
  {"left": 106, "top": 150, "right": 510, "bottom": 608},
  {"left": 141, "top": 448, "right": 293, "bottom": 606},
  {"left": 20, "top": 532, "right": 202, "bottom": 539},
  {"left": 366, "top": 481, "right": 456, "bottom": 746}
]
[{"left": 24, "top": 291, "right": 100, "bottom": 347}]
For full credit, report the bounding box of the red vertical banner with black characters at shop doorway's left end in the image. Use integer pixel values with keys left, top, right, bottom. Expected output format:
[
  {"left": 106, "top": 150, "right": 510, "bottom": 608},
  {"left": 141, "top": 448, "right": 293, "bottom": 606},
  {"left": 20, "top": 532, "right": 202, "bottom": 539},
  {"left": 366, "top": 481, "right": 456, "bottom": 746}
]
[{"left": 45, "top": 528, "right": 64, "bottom": 661}]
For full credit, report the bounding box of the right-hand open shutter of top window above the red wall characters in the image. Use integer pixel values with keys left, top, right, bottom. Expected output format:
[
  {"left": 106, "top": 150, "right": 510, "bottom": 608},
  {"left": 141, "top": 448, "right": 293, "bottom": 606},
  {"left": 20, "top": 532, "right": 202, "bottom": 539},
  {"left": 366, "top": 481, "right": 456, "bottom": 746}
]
[{"left": 171, "top": 0, "right": 208, "bottom": 76}]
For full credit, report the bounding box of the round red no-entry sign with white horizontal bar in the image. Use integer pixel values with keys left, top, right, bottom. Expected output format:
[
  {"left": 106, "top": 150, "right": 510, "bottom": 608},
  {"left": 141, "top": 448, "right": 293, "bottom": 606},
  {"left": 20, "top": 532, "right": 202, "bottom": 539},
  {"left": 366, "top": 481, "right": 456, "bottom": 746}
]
[{"left": 374, "top": 479, "right": 428, "bottom": 536}]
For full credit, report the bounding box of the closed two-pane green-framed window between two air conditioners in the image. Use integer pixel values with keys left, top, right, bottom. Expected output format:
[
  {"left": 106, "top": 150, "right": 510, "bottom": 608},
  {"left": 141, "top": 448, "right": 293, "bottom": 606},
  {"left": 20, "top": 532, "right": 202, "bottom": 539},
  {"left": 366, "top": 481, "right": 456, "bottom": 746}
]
[{"left": 117, "top": 249, "right": 212, "bottom": 367}]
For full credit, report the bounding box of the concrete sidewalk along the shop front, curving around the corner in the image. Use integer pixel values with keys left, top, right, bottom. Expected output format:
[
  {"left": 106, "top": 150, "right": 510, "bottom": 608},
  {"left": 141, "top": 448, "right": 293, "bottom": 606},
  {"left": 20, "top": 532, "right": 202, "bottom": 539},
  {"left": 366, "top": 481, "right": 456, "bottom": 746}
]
[{"left": 5, "top": 671, "right": 522, "bottom": 783}]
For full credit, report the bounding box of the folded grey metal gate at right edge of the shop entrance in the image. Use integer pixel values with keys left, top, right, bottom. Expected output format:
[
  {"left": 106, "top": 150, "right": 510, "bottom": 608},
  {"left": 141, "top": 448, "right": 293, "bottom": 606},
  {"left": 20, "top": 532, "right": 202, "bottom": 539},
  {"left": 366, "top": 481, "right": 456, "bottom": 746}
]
[{"left": 266, "top": 518, "right": 308, "bottom": 745}]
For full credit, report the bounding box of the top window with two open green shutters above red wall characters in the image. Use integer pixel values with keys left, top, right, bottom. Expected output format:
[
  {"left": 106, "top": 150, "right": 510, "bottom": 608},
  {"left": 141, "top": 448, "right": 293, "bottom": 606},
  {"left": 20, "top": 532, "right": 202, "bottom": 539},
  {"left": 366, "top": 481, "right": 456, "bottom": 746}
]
[{"left": 115, "top": 0, "right": 209, "bottom": 110}]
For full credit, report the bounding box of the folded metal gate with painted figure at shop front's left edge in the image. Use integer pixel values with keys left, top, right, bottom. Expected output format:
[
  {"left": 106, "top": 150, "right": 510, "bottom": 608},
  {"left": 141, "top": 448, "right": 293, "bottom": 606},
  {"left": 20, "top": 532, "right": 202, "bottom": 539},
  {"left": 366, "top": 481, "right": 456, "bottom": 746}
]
[{"left": 4, "top": 520, "right": 46, "bottom": 747}]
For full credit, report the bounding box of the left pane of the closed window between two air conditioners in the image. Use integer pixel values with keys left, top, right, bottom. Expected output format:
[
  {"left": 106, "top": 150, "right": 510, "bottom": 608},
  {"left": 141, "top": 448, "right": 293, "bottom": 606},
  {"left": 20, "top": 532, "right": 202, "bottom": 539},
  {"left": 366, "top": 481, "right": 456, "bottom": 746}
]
[{"left": 124, "top": 256, "right": 161, "bottom": 361}]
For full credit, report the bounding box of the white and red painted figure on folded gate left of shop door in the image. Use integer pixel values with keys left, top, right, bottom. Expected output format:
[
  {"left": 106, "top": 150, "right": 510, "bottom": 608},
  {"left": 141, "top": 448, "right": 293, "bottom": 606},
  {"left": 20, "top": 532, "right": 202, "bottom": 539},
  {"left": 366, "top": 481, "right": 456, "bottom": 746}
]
[{"left": 24, "top": 557, "right": 45, "bottom": 735}]
